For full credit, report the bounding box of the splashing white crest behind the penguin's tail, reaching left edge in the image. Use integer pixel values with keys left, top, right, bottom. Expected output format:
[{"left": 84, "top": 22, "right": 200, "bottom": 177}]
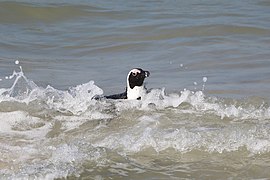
[{"left": 0, "top": 66, "right": 103, "bottom": 114}]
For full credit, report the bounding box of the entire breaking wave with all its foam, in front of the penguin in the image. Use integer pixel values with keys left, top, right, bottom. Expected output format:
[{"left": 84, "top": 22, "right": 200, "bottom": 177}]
[{"left": 0, "top": 62, "right": 270, "bottom": 179}]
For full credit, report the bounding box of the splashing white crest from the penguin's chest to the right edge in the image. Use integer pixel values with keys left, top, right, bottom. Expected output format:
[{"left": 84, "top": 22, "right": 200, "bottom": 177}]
[{"left": 141, "top": 88, "right": 270, "bottom": 119}]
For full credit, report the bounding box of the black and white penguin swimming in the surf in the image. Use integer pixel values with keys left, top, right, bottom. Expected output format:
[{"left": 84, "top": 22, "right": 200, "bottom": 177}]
[{"left": 105, "top": 68, "right": 150, "bottom": 100}]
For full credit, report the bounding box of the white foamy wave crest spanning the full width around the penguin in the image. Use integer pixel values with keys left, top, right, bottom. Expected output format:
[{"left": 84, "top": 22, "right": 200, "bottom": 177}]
[{"left": 0, "top": 66, "right": 270, "bottom": 122}]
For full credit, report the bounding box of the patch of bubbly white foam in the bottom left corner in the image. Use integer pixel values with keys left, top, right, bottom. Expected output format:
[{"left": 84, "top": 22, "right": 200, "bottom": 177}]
[{"left": 0, "top": 141, "right": 106, "bottom": 179}]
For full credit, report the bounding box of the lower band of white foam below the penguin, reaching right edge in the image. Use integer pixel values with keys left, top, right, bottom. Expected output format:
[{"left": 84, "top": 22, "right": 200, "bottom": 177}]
[{"left": 95, "top": 114, "right": 270, "bottom": 154}]
